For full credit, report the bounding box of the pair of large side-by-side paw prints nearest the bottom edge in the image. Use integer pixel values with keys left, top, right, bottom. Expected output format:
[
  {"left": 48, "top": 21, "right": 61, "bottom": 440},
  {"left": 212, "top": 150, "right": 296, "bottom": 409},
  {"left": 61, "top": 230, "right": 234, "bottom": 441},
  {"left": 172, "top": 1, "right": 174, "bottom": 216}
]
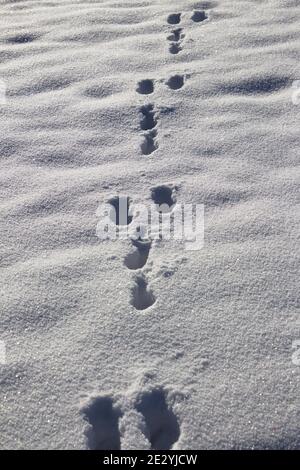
[{"left": 82, "top": 388, "right": 180, "bottom": 450}]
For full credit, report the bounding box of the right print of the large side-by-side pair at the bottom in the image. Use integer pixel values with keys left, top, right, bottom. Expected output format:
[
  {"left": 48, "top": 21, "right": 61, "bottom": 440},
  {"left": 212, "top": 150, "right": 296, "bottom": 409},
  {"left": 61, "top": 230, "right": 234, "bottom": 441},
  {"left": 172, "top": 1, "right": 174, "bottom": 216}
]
[{"left": 136, "top": 389, "right": 180, "bottom": 450}]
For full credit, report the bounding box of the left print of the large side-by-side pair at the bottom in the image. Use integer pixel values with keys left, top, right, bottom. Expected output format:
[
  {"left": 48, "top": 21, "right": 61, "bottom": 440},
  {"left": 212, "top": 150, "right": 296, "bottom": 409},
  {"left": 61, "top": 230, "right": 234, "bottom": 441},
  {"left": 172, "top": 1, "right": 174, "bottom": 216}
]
[{"left": 83, "top": 397, "right": 121, "bottom": 450}]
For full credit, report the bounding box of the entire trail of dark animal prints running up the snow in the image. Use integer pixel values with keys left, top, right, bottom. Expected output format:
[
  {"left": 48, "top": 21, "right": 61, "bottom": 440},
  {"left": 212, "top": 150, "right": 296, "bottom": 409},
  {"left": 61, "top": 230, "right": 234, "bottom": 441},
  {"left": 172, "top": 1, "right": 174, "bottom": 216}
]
[{"left": 80, "top": 2, "right": 218, "bottom": 450}]
